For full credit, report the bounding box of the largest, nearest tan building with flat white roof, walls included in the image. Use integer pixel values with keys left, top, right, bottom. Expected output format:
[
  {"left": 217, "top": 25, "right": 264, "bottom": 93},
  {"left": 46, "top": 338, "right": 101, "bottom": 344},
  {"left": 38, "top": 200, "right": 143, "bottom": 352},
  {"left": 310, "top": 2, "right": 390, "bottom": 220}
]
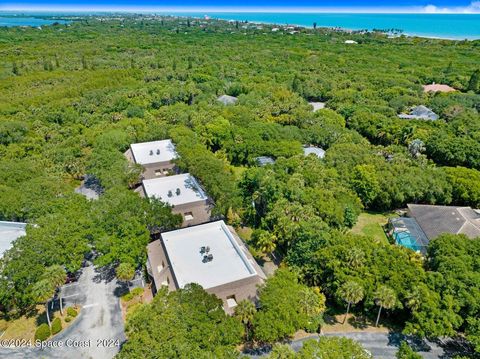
[{"left": 147, "top": 221, "right": 265, "bottom": 314}]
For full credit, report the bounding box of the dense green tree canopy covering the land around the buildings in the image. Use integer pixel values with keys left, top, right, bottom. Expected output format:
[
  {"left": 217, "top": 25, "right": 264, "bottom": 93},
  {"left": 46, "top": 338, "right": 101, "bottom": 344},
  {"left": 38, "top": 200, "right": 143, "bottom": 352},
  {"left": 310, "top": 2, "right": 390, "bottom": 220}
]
[{"left": 0, "top": 16, "right": 480, "bottom": 357}]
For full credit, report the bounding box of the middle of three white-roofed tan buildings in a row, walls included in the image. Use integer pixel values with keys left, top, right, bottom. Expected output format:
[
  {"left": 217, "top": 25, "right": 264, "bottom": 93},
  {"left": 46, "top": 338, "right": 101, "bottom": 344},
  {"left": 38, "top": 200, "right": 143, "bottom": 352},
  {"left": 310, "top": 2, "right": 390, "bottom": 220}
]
[{"left": 137, "top": 173, "right": 212, "bottom": 227}]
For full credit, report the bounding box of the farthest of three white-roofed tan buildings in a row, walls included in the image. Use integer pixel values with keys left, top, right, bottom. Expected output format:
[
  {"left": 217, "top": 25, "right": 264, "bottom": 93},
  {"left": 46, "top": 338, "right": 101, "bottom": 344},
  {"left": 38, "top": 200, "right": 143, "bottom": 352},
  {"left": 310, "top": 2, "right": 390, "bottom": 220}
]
[{"left": 125, "top": 140, "right": 178, "bottom": 179}]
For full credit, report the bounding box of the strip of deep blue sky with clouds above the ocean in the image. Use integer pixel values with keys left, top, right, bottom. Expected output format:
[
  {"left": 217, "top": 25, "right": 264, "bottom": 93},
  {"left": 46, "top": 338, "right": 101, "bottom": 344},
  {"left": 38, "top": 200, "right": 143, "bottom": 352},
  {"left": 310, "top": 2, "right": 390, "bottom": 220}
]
[{"left": 0, "top": 0, "right": 480, "bottom": 13}]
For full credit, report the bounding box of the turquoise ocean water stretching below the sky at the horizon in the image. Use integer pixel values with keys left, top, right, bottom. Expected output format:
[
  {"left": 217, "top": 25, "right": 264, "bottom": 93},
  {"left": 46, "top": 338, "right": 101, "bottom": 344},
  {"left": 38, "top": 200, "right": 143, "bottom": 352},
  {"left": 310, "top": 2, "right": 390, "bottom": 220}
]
[{"left": 0, "top": 11, "right": 480, "bottom": 40}]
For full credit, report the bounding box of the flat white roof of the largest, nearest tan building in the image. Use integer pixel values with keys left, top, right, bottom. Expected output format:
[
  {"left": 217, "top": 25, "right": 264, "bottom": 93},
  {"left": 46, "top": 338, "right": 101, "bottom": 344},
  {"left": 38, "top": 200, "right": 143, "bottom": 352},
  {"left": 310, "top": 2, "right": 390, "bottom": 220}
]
[{"left": 162, "top": 221, "right": 257, "bottom": 289}]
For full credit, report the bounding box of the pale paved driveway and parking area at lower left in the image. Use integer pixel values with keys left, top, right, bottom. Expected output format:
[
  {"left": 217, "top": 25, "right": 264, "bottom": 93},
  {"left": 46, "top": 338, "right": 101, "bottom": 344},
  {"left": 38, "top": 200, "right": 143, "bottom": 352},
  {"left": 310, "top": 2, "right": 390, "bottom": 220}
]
[{"left": 0, "top": 265, "right": 126, "bottom": 359}]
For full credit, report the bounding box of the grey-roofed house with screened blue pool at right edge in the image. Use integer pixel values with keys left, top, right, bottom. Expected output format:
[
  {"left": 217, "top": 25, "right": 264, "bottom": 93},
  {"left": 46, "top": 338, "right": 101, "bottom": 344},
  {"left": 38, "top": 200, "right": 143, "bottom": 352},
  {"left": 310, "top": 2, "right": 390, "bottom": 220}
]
[{"left": 390, "top": 204, "right": 480, "bottom": 253}]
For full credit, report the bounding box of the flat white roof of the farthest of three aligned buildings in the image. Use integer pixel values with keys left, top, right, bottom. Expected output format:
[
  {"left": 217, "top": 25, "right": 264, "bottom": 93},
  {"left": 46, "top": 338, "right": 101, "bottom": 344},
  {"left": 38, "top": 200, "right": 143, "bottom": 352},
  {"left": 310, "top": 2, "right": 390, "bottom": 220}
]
[{"left": 130, "top": 140, "right": 178, "bottom": 165}]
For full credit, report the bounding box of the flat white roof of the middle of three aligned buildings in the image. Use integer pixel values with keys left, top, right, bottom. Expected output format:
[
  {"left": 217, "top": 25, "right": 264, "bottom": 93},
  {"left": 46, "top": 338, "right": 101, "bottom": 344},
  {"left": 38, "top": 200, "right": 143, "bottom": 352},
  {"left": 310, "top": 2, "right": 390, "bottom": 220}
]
[{"left": 142, "top": 173, "right": 207, "bottom": 206}]
